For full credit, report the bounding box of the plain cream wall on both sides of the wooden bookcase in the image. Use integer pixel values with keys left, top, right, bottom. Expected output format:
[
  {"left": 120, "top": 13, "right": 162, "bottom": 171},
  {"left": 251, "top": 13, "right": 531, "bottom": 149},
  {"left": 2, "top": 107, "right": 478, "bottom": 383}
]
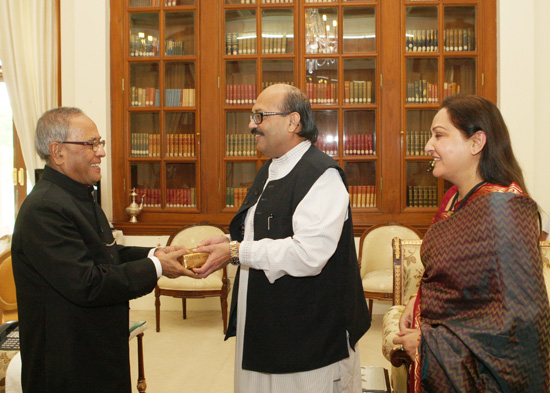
[{"left": 61, "top": 0, "right": 550, "bottom": 309}]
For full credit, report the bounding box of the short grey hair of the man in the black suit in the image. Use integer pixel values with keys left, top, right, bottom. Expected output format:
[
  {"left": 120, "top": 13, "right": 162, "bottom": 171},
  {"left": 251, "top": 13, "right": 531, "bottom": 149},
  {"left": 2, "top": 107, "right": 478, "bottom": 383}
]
[{"left": 34, "top": 106, "right": 85, "bottom": 160}]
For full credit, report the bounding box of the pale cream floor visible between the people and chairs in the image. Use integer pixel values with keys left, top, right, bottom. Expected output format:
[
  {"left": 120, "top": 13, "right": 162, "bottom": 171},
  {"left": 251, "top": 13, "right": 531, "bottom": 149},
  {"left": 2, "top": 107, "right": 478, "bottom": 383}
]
[{"left": 130, "top": 303, "right": 390, "bottom": 393}]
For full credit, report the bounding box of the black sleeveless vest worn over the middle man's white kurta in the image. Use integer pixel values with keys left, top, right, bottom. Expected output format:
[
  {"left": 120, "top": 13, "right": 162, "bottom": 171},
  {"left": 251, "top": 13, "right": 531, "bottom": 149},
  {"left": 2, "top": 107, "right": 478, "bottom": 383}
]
[{"left": 226, "top": 146, "right": 370, "bottom": 374}]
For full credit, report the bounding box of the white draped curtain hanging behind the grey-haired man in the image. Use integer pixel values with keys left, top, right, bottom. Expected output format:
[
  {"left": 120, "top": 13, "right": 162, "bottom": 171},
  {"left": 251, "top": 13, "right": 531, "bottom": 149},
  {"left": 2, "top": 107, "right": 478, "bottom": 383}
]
[{"left": 0, "top": 0, "right": 57, "bottom": 183}]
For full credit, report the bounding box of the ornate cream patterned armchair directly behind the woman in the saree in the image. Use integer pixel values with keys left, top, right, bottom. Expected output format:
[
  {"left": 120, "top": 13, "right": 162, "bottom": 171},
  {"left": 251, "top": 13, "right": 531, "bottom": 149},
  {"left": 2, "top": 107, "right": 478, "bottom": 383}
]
[{"left": 382, "top": 238, "right": 550, "bottom": 393}]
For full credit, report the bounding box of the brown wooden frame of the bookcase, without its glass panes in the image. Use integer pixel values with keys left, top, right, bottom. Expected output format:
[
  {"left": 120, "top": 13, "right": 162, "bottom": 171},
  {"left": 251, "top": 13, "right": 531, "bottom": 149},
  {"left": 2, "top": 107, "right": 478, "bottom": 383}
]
[{"left": 111, "top": 0, "right": 497, "bottom": 235}]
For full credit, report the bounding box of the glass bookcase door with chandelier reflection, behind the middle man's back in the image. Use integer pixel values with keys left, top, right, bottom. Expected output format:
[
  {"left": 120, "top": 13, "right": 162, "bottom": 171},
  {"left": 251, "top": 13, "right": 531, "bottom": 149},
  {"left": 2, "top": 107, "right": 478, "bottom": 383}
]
[{"left": 303, "top": 1, "right": 380, "bottom": 209}]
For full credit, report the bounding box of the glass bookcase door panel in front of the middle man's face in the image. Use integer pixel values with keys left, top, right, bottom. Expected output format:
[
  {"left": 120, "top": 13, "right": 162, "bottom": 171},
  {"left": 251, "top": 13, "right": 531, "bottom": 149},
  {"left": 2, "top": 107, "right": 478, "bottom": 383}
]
[{"left": 220, "top": 0, "right": 298, "bottom": 212}]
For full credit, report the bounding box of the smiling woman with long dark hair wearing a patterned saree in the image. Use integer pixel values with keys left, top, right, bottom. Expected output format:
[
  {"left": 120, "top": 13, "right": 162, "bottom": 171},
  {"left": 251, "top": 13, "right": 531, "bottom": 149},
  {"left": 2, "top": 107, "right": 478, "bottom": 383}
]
[{"left": 394, "top": 96, "right": 550, "bottom": 393}]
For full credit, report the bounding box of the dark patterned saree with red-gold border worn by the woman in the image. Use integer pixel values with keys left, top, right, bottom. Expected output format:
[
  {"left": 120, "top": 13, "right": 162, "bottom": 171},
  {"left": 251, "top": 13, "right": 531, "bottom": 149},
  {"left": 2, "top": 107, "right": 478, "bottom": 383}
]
[{"left": 418, "top": 184, "right": 550, "bottom": 393}]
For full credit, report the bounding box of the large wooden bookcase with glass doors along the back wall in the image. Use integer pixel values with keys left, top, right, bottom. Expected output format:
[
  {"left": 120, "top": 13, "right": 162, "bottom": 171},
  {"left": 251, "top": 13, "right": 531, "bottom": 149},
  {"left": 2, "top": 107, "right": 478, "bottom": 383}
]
[{"left": 111, "top": 0, "right": 496, "bottom": 234}]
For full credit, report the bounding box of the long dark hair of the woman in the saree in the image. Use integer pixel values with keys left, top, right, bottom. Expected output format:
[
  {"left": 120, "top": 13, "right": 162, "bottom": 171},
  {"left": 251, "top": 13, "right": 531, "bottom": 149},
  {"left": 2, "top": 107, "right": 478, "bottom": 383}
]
[{"left": 441, "top": 95, "right": 527, "bottom": 193}]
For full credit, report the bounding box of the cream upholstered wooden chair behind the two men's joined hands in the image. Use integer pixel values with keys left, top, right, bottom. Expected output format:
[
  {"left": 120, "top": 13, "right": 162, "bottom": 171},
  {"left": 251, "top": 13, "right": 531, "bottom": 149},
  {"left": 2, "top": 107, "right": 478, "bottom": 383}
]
[{"left": 155, "top": 222, "right": 229, "bottom": 333}]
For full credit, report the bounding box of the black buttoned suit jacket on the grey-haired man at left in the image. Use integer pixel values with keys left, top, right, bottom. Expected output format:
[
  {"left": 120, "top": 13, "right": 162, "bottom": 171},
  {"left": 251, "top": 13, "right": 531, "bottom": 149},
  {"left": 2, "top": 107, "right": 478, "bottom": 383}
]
[{"left": 12, "top": 166, "right": 157, "bottom": 393}]
